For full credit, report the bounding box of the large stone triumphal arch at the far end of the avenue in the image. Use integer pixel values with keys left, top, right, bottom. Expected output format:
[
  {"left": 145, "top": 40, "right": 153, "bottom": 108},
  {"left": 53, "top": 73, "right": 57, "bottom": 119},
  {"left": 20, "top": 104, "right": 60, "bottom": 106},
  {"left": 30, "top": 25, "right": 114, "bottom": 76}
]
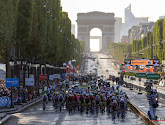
[{"left": 77, "top": 11, "right": 115, "bottom": 52}]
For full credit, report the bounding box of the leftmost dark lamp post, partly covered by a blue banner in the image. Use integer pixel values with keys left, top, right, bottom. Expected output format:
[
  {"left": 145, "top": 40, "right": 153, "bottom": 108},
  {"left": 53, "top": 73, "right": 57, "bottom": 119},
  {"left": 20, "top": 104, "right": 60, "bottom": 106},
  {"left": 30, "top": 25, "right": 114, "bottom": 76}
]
[{"left": 9, "top": 57, "right": 14, "bottom": 108}]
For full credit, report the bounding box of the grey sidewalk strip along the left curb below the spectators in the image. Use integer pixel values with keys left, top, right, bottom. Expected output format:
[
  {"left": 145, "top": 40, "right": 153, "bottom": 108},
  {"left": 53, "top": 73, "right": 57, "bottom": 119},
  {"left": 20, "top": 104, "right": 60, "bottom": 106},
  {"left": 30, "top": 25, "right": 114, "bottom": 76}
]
[{"left": 0, "top": 97, "right": 42, "bottom": 124}]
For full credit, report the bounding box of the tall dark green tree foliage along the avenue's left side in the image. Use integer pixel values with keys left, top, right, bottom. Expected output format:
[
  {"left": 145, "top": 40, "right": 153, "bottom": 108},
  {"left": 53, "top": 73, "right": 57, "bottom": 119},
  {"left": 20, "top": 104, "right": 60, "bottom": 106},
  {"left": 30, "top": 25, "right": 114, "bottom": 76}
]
[{"left": 0, "top": 0, "right": 83, "bottom": 65}]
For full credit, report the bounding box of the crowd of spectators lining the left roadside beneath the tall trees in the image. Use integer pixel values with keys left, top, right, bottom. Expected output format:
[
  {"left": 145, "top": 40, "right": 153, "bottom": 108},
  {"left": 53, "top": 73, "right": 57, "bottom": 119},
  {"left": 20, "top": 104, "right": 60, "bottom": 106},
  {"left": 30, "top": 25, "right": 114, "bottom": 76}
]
[{"left": 0, "top": 80, "right": 68, "bottom": 104}]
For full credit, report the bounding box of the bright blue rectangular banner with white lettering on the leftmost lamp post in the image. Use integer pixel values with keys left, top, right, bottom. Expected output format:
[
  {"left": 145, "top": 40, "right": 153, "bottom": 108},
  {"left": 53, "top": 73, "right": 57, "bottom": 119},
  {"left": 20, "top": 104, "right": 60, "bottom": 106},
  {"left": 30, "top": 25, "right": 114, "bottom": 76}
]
[{"left": 6, "top": 78, "right": 19, "bottom": 87}]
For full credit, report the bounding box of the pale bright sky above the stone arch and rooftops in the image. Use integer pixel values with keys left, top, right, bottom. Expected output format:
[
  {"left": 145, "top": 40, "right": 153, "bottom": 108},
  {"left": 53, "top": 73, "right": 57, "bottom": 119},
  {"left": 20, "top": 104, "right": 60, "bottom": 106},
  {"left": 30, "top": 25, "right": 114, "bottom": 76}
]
[{"left": 61, "top": 0, "right": 165, "bottom": 24}]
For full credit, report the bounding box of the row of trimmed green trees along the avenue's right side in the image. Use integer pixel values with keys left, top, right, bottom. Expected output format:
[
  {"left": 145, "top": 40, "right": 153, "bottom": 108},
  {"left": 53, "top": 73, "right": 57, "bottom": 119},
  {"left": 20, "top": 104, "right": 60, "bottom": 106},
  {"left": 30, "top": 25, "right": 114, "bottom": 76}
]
[{"left": 109, "top": 19, "right": 165, "bottom": 61}]
